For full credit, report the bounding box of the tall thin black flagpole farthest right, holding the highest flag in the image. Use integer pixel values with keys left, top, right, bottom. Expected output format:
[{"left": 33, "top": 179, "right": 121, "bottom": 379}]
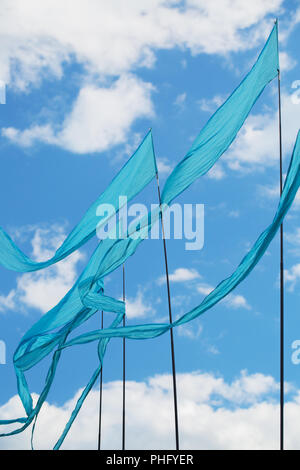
[{"left": 276, "top": 19, "right": 284, "bottom": 450}]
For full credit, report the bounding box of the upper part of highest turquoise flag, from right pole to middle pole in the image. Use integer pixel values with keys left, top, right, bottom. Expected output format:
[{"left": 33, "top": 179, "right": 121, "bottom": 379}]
[{"left": 162, "top": 23, "right": 279, "bottom": 204}]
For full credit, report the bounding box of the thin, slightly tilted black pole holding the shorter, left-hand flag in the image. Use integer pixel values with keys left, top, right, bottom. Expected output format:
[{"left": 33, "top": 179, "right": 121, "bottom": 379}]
[{"left": 152, "top": 131, "right": 179, "bottom": 450}]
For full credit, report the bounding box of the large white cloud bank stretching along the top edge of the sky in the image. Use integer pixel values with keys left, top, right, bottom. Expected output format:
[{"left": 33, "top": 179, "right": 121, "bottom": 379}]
[{"left": 0, "top": 0, "right": 283, "bottom": 89}]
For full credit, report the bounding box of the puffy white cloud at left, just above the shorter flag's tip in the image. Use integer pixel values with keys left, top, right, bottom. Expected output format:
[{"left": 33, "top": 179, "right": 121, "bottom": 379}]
[{"left": 2, "top": 75, "right": 154, "bottom": 153}]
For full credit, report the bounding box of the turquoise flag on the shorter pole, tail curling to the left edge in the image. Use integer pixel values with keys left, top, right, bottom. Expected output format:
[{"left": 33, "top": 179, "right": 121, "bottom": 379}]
[{"left": 0, "top": 131, "right": 156, "bottom": 272}]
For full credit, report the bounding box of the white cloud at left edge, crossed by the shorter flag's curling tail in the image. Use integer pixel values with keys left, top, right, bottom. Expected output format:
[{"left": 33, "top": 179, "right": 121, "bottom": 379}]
[{"left": 0, "top": 225, "right": 84, "bottom": 313}]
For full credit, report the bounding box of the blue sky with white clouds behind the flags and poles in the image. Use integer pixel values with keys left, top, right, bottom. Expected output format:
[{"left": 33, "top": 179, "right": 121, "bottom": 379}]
[{"left": 0, "top": 0, "right": 300, "bottom": 448}]
